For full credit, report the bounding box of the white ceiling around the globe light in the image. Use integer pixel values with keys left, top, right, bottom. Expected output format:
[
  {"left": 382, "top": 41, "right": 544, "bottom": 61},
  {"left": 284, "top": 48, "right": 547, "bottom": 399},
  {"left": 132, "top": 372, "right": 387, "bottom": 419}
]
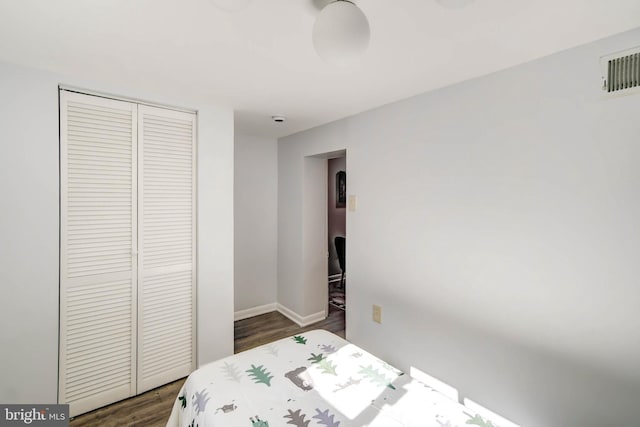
[{"left": 0, "top": 0, "right": 640, "bottom": 137}]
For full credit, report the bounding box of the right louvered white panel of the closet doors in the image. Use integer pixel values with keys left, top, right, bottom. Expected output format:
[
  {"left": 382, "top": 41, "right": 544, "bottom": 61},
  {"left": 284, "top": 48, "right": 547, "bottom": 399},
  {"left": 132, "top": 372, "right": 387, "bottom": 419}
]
[{"left": 138, "top": 105, "right": 196, "bottom": 393}]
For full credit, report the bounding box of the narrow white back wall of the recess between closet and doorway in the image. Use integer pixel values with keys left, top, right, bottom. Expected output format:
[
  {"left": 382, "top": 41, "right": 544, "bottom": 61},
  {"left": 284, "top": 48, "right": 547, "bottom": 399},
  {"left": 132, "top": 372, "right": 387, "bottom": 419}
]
[{"left": 234, "top": 133, "right": 278, "bottom": 312}]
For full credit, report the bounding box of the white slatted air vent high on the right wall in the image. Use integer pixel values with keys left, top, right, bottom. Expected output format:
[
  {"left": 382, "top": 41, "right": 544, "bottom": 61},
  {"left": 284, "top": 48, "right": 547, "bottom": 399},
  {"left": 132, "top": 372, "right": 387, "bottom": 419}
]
[{"left": 600, "top": 47, "right": 640, "bottom": 94}]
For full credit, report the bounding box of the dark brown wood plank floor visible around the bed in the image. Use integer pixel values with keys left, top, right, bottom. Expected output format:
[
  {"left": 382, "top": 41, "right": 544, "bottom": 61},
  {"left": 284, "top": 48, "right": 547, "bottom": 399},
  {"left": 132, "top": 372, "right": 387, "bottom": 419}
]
[{"left": 70, "top": 306, "right": 345, "bottom": 427}]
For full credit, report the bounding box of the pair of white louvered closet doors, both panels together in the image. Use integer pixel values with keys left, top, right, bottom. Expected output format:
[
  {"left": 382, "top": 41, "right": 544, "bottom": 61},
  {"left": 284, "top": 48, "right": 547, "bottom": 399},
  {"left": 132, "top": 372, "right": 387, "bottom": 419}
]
[{"left": 59, "top": 91, "right": 195, "bottom": 416}]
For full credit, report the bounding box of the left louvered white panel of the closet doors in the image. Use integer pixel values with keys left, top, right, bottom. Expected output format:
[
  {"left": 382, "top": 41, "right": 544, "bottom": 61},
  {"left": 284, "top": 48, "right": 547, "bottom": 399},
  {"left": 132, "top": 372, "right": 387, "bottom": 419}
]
[{"left": 59, "top": 91, "right": 137, "bottom": 416}]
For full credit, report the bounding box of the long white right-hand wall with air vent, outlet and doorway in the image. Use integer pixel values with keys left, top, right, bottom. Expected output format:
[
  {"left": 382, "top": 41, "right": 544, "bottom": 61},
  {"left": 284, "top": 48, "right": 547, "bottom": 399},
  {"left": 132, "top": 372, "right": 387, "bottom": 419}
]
[{"left": 278, "top": 29, "right": 640, "bottom": 427}]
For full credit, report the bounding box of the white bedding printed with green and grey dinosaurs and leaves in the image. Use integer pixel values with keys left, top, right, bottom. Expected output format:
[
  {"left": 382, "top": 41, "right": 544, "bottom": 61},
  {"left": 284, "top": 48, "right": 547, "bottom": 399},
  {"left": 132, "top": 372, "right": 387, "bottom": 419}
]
[{"left": 167, "top": 330, "right": 497, "bottom": 427}]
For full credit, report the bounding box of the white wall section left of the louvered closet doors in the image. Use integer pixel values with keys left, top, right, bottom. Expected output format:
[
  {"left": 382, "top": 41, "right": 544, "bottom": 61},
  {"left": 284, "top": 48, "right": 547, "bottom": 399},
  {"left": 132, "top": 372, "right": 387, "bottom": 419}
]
[{"left": 0, "top": 64, "right": 59, "bottom": 403}]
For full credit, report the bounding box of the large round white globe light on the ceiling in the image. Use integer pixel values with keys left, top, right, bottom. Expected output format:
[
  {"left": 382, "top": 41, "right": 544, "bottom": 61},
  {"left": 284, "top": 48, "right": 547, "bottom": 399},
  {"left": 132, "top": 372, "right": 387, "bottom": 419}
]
[{"left": 313, "top": 0, "right": 370, "bottom": 65}]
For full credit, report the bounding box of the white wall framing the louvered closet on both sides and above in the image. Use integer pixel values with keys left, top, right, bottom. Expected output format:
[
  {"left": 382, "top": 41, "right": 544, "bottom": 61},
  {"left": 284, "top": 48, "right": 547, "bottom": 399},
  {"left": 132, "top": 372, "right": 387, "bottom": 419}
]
[{"left": 0, "top": 59, "right": 233, "bottom": 403}]
